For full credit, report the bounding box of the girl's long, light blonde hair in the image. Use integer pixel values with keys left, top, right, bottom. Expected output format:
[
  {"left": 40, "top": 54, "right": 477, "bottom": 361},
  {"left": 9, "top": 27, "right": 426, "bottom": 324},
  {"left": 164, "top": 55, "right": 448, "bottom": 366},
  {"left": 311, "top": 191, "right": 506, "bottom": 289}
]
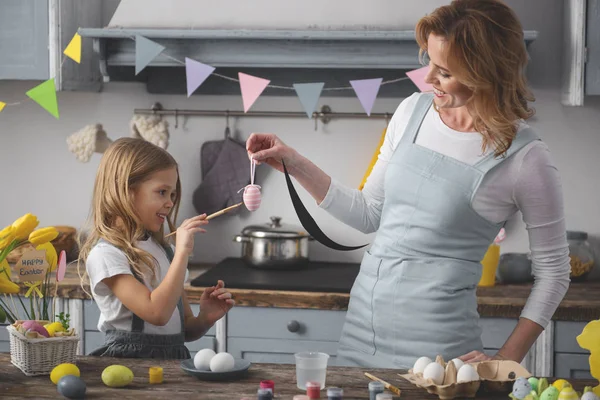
[{"left": 77, "top": 138, "right": 181, "bottom": 285}]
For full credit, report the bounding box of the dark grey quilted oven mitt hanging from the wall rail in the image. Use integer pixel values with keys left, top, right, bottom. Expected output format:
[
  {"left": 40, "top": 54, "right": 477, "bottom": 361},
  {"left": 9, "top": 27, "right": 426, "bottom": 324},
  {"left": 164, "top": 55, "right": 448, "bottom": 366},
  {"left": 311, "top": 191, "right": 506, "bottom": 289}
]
[{"left": 192, "top": 139, "right": 250, "bottom": 215}]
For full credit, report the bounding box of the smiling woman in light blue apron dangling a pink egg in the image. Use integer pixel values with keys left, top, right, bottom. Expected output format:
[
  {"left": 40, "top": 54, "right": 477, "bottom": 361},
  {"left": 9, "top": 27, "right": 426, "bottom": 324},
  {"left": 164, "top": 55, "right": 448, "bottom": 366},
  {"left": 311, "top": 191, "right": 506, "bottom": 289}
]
[{"left": 247, "top": 0, "right": 569, "bottom": 368}]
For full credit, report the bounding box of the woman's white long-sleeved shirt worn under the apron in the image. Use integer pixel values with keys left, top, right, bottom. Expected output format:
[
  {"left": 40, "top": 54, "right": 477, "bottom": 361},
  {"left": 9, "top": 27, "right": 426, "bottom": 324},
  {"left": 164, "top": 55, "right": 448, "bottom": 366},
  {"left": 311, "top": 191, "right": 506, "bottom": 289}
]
[{"left": 320, "top": 93, "right": 570, "bottom": 327}]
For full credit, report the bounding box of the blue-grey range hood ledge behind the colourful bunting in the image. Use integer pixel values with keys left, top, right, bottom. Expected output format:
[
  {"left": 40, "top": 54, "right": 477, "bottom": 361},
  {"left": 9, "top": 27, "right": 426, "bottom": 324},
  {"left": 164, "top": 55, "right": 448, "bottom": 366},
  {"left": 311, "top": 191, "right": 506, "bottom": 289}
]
[{"left": 79, "top": 28, "right": 537, "bottom": 96}]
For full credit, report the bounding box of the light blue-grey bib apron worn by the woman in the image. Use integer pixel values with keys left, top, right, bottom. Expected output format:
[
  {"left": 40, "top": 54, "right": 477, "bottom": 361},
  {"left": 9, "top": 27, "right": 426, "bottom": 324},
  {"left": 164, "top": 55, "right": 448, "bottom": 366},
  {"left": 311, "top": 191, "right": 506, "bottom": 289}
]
[{"left": 338, "top": 94, "right": 538, "bottom": 368}]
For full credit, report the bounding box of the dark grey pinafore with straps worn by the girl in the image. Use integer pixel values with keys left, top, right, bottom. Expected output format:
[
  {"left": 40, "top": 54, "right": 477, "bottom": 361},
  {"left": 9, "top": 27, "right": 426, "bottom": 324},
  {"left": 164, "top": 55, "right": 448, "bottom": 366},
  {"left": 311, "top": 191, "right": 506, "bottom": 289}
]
[{"left": 89, "top": 247, "right": 190, "bottom": 360}]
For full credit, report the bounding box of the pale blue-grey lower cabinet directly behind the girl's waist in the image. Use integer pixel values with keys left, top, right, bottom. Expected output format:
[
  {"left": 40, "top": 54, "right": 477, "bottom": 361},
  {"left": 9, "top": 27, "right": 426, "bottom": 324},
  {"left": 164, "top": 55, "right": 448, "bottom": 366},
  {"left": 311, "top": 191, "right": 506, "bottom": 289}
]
[{"left": 82, "top": 300, "right": 217, "bottom": 357}]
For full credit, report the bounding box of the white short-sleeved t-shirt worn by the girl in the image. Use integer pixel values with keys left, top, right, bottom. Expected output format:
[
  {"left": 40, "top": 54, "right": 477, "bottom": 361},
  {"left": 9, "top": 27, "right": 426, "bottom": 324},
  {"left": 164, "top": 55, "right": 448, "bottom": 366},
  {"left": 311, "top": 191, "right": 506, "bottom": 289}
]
[{"left": 85, "top": 239, "right": 181, "bottom": 335}]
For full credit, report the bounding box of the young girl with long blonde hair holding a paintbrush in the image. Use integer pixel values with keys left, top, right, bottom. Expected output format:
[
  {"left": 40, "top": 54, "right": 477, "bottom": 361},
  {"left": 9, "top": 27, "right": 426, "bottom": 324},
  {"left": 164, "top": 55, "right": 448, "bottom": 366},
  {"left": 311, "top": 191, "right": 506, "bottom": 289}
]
[{"left": 79, "top": 138, "right": 234, "bottom": 359}]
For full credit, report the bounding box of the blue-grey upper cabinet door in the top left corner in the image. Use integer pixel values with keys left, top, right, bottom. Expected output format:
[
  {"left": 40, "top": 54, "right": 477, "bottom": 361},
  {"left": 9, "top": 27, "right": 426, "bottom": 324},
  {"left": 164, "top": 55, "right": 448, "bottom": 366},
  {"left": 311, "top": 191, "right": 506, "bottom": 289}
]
[{"left": 0, "top": 0, "right": 49, "bottom": 80}]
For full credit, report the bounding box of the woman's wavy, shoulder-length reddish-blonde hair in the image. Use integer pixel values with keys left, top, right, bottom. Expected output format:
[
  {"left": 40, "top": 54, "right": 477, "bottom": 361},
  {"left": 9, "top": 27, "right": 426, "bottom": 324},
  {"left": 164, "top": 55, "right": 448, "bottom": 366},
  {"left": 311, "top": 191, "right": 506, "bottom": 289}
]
[{"left": 416, "top": 0, "right": 535, "bottom": 156}]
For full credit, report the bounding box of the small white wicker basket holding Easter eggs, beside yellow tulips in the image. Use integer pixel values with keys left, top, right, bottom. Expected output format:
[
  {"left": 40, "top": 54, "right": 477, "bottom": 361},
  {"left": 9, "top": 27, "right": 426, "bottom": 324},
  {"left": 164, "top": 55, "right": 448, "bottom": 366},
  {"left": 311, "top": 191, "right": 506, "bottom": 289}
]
[{"left": 6, "top": 325, "right": 79, "bottom": 376}]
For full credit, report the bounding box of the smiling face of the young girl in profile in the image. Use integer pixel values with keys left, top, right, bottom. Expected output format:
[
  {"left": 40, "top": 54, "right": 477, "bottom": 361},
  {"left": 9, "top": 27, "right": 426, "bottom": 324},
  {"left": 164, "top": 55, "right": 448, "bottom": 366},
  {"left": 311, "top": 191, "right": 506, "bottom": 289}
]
[{"left": 133, "top": 167, "right": 178, "bottom": 232}]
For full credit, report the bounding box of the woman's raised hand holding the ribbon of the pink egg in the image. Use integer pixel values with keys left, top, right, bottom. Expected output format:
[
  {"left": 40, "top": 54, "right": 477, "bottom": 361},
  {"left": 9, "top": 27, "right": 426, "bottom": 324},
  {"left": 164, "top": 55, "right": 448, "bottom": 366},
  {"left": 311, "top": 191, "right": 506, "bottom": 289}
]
[{"left": 246, "top": 133, "right": 300, "bottom": 175}]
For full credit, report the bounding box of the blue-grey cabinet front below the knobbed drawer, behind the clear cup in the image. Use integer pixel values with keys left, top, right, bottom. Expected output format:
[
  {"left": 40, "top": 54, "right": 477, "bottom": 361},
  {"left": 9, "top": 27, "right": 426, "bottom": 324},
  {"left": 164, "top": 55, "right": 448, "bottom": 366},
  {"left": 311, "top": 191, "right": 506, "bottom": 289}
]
[{"left": 227, "top": 338, "right": 338, "bottom": 365}]
